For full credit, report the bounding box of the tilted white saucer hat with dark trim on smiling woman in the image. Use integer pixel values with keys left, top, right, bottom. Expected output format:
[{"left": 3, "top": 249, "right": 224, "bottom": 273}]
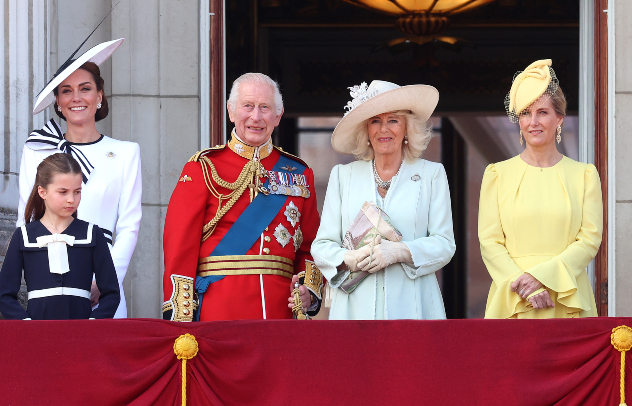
[{"left": 33, "top": 38, "right": 125, "bottom": 115}]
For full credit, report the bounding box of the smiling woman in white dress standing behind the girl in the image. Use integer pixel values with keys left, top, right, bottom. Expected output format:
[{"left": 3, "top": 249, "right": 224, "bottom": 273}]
[{"left": 17, "top": 39, "right": 142, "bottom": 318}]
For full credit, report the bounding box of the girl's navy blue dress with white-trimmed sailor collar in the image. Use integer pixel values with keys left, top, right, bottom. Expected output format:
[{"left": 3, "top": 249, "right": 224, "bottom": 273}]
[{"left": 0, "top": 219, "right": 120, "bottom": 320}]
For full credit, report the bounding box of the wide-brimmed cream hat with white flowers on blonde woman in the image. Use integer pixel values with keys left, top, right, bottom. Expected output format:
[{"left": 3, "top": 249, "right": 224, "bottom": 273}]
[{"left": 331, "top": 80, "right": 439, "bottom": 154}]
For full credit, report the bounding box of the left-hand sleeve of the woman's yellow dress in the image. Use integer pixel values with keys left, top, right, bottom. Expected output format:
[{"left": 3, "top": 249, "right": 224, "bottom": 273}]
[{"left": 478, "top": 164, "right": 525, "bottom": 319}]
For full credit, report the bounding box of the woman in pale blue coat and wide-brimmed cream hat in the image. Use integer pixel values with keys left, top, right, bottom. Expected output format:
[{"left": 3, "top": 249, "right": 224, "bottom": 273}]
[{"left": 312, "top": 81, "right": 455, "bottom": 320}]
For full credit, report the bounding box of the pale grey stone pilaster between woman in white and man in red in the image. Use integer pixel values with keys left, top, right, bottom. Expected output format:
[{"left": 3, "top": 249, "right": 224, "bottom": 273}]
[{"left": 111, "top": 0, "right": 200, "bottom": 317}]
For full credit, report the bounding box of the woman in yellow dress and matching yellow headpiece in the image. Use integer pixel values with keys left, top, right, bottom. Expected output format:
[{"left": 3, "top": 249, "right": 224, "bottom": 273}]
[{"left": 478, "top": 59, "right": 603, "bottom": 319}]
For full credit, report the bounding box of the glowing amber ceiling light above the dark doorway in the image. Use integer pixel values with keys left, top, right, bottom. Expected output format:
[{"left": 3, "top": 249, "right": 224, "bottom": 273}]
[{"left": 344, "top": 0, "right": 494, "bottom": 37}]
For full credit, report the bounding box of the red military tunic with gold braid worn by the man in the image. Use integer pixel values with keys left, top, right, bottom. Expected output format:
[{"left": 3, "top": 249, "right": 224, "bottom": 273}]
[{"left": 163, "top": 147, "right": 320, "bottom": 321}]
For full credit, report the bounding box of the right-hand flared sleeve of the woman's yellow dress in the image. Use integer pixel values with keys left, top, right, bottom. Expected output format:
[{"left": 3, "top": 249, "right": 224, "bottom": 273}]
[{"left": 526, "top": 165, "right": 603, "bottom": 316}]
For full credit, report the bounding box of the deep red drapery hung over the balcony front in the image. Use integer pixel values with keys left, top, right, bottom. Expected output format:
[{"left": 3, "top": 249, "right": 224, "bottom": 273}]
[{"left": 0, "top": 318, "right": 632, "bottom": 406}]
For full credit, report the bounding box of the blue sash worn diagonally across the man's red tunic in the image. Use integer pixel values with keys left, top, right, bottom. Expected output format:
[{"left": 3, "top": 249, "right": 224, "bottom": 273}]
[{"left": 194, "top": 155, "right": 306, "bottom": 321}]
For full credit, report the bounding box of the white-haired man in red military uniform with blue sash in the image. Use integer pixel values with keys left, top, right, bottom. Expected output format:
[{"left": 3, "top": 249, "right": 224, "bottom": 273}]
[{"left": 162, "top": 73, "right": 322, "bottom": 321}]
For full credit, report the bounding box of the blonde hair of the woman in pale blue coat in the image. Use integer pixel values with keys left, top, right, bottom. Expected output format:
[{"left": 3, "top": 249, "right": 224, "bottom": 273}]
[{"left": 352, "top": 110, "right": 432, "bottom": 162}]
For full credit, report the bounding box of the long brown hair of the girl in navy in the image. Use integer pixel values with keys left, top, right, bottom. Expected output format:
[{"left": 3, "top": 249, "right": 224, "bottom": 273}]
[{"left": 24, "top": 152, "right": 81, "bottom": 223}]
